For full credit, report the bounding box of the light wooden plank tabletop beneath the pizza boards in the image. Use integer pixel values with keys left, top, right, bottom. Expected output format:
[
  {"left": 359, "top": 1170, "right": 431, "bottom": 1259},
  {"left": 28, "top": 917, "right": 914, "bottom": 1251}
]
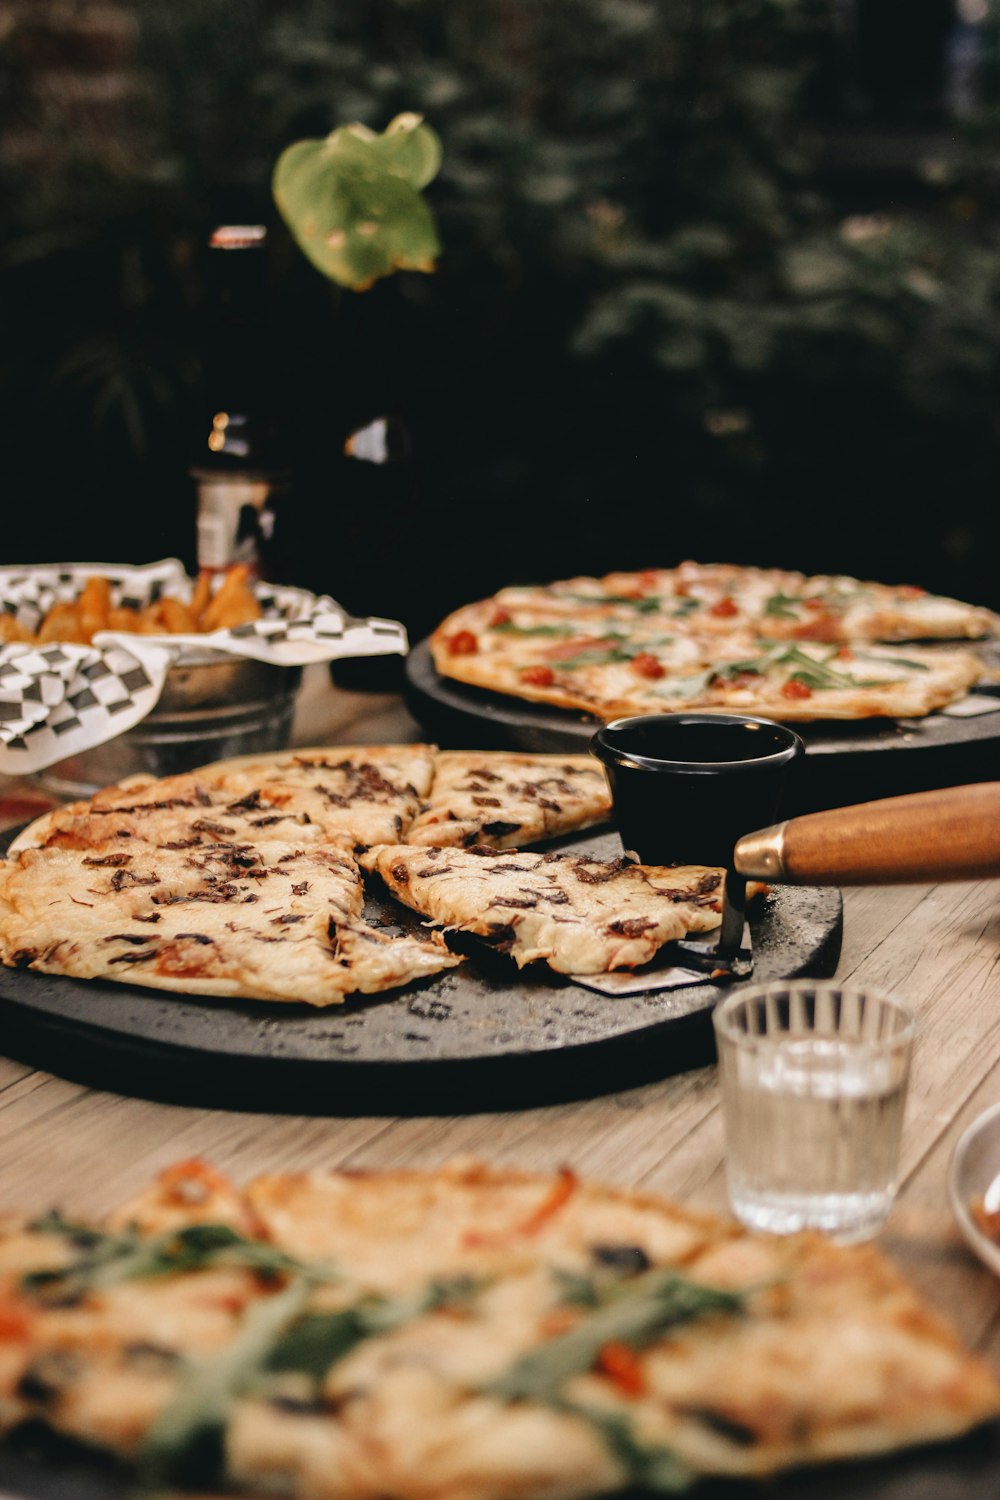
[{"left": 0, "top": 669, "right": 1000, "bottom": 1493}]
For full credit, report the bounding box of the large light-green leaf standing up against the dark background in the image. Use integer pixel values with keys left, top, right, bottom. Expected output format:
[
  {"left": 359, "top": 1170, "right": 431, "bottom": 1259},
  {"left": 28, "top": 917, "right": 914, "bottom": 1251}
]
[{"left": 271, "top": 114, "right": 441, "bottom": 291}]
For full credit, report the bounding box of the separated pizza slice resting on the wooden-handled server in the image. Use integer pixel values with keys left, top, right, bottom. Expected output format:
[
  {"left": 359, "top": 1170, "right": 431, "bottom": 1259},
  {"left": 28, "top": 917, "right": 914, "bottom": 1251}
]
[{"left": 361, "top": 845, "right": 734, "bottom": 974}]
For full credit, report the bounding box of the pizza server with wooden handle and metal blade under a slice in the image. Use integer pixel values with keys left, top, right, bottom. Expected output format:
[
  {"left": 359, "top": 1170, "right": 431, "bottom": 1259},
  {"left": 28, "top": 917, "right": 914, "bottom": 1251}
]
[{"left": 573, "top": 782, "right": 1000, "bottom": 995}]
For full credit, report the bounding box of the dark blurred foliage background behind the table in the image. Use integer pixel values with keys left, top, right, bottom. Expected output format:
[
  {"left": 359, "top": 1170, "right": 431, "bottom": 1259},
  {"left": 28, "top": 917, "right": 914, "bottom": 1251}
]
[{"left": 0, "top": 0, "right": 1000, "bottom": 638}]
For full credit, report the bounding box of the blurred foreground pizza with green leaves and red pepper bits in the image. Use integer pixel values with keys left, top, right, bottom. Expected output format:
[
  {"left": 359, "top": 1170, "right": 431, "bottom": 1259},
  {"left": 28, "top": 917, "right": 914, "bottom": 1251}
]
[{"left": 0, "top": 1161, "right": 1000, "bottom": 1500}]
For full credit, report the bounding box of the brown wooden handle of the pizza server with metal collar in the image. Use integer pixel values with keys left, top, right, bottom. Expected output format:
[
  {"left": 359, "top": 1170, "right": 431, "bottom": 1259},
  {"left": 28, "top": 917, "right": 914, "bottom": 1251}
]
[{"left": 735, "top": 782, "right": 1000, "bottom": 885}]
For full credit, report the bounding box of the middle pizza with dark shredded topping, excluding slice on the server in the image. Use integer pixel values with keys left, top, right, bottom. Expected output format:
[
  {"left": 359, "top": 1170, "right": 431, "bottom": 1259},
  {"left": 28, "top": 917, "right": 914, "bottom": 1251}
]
[{"left": 0, "top": 744, "right": 620, "bottom": 1005}]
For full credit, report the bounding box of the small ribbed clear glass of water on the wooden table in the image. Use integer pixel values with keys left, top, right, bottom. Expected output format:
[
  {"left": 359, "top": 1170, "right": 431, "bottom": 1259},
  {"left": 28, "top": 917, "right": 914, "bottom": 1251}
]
[{"left": 712, "top": 980, "right": 916, "bottom": 1242}]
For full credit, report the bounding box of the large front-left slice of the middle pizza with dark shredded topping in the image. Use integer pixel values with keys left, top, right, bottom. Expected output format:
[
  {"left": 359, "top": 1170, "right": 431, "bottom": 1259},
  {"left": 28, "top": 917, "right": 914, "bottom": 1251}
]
[{"left": 0, "top": 837, "right": 459, "bottom": 1005}]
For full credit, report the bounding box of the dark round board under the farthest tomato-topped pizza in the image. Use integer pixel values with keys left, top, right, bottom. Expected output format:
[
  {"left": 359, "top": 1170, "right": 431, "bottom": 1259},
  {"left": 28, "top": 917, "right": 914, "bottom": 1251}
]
[{"left": 405, "top": 641, "right": 1000, "bottom": 833}]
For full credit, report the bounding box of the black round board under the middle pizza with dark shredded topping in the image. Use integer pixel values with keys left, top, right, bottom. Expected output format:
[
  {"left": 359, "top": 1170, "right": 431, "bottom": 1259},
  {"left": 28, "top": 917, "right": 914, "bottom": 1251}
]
[{"left": 0, "top": 833, "right": 843, "bottom": 1115}]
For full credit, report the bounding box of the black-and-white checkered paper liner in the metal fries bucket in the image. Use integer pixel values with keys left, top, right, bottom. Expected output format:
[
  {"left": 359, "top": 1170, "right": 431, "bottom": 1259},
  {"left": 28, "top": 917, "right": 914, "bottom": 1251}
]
[{"left": 0, "top": 558, "right": 408, "bottom": 776}]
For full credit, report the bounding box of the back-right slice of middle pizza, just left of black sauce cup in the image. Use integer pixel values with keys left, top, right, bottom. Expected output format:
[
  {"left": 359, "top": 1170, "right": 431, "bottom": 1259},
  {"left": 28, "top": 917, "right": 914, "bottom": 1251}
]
[{"left": 403, "top": 750, "right": 612, "bottom": 849}]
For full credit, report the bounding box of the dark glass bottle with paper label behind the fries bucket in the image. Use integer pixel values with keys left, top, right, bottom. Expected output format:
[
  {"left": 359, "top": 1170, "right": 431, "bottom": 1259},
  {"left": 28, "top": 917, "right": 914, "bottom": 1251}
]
[{"left": 190, "top": 225, "right": 295, "bottom": 584}]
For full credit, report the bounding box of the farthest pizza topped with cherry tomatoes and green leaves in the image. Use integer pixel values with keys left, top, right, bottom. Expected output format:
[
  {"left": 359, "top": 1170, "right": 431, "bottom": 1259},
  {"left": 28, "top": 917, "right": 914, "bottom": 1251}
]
[{"left": 430, "top": 561, "right": 1000, "bottom": 722}]
